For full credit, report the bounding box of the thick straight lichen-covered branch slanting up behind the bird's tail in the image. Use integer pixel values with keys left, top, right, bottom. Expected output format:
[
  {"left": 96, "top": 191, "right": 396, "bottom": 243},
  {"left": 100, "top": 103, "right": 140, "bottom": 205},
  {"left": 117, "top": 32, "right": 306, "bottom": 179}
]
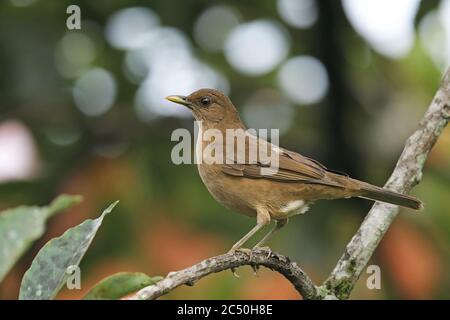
[{"left": 323, "top": 69, "right": 450, "bottom": 299}]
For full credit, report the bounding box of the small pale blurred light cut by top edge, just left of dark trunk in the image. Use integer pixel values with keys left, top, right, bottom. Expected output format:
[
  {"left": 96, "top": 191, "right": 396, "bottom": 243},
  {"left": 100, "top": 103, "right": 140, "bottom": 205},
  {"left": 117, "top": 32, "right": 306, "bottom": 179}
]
[{"left": 277, "top": 0, "right": 319, "bottom": 29}]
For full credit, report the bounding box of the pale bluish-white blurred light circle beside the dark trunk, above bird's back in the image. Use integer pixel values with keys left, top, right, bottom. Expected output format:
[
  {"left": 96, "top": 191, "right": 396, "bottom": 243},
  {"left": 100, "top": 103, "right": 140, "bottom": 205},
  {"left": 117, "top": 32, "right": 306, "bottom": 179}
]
[{"left": 278, "top": 56, "right": 329, "bottom": 104}]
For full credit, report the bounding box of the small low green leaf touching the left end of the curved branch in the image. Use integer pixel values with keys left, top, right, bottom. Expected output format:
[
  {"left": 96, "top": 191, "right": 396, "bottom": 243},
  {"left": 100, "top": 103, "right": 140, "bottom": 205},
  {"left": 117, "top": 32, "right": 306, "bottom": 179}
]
[{"left": 84, "top": 272, "right": 162, "bottom": 300}]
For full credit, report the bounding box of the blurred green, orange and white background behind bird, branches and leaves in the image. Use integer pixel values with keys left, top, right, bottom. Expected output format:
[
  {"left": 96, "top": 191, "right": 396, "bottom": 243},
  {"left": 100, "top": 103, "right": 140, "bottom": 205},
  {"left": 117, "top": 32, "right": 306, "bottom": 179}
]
[{"left": 0, "top": 0, "right": 450, "bottom": 299}]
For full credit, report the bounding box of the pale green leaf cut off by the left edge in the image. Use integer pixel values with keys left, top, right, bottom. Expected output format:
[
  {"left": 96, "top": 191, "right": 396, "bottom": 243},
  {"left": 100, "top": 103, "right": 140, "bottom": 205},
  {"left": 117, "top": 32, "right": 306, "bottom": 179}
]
[{"left": 0, "top": 195, "right": 82, "bottom": 282}]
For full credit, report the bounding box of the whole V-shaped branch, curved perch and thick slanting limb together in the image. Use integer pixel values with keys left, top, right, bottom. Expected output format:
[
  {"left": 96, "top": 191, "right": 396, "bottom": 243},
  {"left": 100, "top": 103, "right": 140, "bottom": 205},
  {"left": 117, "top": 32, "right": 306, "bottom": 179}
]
[{"left": 131, "top": 69, "right": 450, "bottom": 299}]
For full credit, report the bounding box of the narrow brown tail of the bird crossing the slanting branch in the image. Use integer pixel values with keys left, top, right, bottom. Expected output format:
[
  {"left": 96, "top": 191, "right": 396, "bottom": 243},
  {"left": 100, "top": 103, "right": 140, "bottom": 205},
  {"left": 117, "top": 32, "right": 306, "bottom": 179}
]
[{"left": 359, "top": 183, "right": 423, "bottom": 210}]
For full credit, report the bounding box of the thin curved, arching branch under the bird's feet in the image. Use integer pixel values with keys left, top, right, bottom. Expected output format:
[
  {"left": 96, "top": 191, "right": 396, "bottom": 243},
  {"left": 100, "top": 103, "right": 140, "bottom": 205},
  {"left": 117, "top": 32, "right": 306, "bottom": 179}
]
[{"left": 131, "top": 248, "right": 318, "bottom": 300}]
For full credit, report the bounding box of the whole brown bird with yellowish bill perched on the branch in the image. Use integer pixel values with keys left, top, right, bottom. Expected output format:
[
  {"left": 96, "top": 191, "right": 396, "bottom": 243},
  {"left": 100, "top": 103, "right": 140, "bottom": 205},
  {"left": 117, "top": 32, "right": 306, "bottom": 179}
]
[{"left": 166, "top": 89, "right": 422, "bottom": 252}]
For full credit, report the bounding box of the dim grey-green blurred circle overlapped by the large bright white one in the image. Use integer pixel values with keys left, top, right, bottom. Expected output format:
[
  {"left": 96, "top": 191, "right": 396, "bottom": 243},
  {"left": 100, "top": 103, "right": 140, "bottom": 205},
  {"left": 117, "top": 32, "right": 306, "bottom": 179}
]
[{"left": 194, "top": 5, "right": 241, "bottom": 52}]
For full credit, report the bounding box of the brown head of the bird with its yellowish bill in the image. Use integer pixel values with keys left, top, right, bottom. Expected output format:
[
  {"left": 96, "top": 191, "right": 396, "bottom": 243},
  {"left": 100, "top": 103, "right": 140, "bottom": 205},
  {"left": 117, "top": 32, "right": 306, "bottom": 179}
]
[{"left": 166, "top": 89, "right": 242, "bottom": 128}]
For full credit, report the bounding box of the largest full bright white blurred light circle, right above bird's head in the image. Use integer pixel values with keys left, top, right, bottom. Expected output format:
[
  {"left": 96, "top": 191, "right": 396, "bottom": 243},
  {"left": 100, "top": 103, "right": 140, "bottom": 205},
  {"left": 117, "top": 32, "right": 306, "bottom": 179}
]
[{"left": 225, "top": 20, "right": 289, "bottom": 76}]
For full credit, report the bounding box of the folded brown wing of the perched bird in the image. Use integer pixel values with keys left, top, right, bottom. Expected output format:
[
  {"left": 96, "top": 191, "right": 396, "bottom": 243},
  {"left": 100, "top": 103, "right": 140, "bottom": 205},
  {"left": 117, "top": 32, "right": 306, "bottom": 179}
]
[{"left": 222, "top": 134, "right": 344, "bottom": 187}]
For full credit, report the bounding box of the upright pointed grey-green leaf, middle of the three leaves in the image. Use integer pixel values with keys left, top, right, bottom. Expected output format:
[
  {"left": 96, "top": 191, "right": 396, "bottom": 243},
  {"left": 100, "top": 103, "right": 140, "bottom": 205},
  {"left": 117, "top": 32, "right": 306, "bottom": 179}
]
[{"left": 19, "top": 201, "right": 118, "bottom": 300}]
